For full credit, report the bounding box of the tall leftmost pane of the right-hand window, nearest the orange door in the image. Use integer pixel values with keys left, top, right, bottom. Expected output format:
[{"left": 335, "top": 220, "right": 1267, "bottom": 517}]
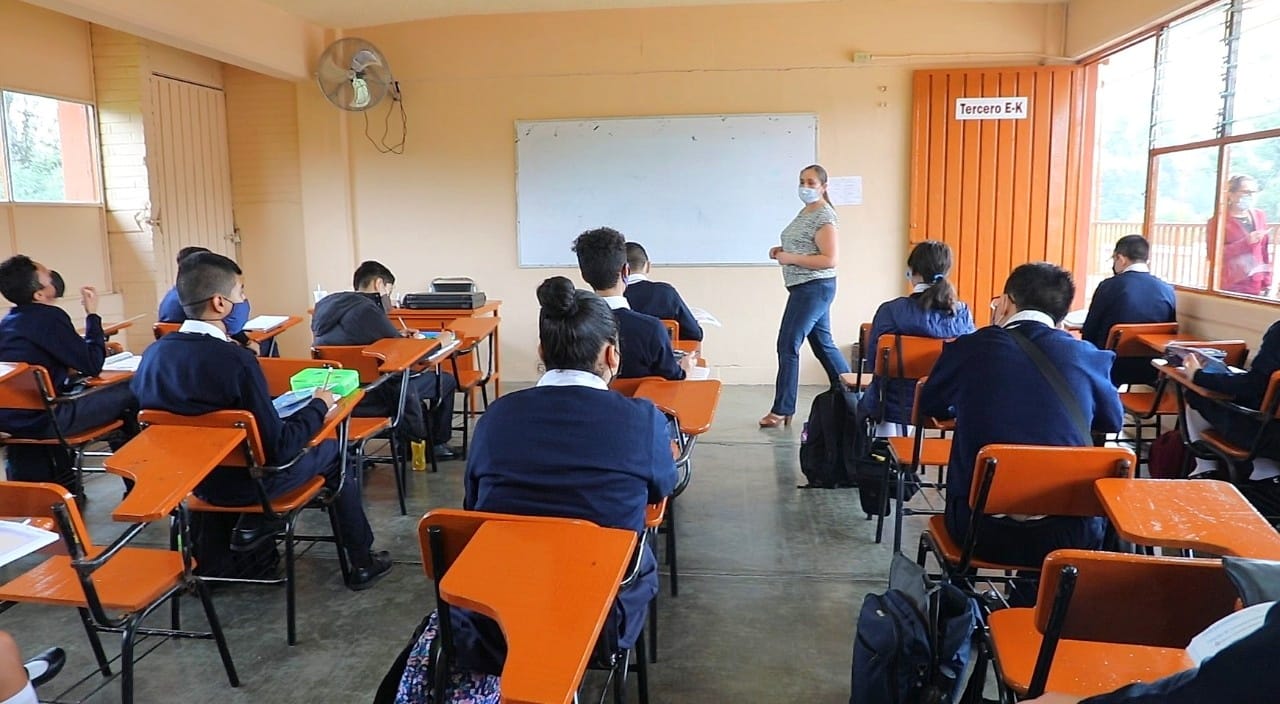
[{"left": 1084, "top": 38, "right": 1156, "bottom": 297}]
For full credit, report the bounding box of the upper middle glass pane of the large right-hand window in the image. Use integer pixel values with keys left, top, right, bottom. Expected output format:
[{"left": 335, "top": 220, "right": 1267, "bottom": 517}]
[{"left": 1155, "top": 4, "right": 1226, "bottom": 146}]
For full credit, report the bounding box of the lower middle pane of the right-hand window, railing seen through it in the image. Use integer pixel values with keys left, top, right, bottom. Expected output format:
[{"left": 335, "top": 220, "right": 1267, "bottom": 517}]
[{"left": 1148, "top": 147, "right": 1219, "bottom": 288}]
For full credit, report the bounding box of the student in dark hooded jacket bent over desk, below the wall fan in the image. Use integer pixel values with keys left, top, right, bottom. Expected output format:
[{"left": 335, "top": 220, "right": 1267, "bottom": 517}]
[{"left": 311, "top": 261, "right": 458, "bottom": 460}]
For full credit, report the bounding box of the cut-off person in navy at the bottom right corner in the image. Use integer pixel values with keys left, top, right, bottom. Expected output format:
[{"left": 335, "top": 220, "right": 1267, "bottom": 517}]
[{"left": 1023, "top": 604, "right": 1280, "bottom": 704}]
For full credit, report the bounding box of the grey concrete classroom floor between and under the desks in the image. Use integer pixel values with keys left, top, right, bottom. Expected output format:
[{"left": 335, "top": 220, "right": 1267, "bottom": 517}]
[{"left": 0, "top": 387, "right": 920, "bottom": 704}]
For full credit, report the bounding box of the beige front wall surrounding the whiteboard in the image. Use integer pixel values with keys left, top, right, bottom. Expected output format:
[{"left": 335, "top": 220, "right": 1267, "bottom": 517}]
[{"left": 327, "top": 1, "right": 1061, "bottom": 383}]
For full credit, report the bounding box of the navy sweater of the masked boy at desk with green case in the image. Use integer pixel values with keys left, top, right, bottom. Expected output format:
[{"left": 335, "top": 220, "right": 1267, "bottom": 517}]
[{"left": 132, "top": 333, "right": 328, "bottom": 465}]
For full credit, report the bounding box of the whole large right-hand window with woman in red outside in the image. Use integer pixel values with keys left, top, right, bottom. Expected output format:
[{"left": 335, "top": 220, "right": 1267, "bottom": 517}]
[{"left": 1087, "top": 0, "right": 1280, "bottom": 301}]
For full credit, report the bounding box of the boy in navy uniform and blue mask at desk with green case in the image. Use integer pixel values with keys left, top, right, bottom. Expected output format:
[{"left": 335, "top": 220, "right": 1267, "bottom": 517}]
[{"left": 133, "top": 252, "right": 392, "bottom": 590}]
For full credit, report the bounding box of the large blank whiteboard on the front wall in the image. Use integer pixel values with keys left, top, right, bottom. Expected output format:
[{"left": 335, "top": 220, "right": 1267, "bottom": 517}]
[{"left": 516, "top": 114, "right": 818, "bottom": 266}]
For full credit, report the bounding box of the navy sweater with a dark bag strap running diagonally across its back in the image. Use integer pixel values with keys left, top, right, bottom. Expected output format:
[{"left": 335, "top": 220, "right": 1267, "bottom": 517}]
[{"left": 920, "top": 323, "right": 1123, "bottom": 539}]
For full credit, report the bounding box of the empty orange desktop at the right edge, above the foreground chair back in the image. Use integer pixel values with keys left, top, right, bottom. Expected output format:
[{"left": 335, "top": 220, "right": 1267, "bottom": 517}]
[{"left": 1093, "top": 479, "right": 1280, "bottom": 559}]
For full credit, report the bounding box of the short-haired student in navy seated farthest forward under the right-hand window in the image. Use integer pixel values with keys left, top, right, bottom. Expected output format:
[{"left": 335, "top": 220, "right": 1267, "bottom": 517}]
[{"left": 1080, "top": 234, "right": 1178, "bottom": 387}]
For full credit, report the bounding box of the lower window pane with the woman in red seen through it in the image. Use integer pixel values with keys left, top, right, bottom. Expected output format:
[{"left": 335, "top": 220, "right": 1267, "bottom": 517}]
[{"left": 1217, "top": 138, "right": 1280, "bottom": 300}]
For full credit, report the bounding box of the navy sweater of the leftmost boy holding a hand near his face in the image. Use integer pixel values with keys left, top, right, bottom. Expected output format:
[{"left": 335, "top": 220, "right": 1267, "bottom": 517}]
[{"left": 0, "top": 302, "right": 106, "bottom": 435}]
